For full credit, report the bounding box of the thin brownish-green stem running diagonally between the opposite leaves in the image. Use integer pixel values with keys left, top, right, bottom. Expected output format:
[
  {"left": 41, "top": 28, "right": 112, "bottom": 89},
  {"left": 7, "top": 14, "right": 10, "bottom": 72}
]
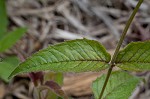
[{"left": 99, "top": 0, "right": 144, "bottom": 99}]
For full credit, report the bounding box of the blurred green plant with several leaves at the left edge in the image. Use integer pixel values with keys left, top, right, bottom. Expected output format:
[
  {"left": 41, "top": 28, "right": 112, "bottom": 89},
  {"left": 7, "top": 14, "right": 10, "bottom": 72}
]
[{"left": 0, "top": 0, "right": 26, "bottom": 82}]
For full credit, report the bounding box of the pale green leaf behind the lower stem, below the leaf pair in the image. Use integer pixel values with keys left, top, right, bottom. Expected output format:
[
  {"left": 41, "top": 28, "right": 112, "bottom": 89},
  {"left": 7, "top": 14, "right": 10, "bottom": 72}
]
[{"left": 92, "top": 71, "right": 140, "bottom": 99}]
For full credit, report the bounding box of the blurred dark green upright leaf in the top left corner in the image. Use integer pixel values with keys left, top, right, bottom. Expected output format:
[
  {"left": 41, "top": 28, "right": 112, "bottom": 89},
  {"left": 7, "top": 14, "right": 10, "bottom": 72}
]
[{"left": 0, "top": 0, "right": 8, "bottom": 39}]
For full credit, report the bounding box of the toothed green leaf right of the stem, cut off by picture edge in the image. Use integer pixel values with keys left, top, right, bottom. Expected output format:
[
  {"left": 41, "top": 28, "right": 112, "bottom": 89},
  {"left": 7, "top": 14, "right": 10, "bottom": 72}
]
[{"left": 115, "top": 41, "right": 150, "bottom": 71}]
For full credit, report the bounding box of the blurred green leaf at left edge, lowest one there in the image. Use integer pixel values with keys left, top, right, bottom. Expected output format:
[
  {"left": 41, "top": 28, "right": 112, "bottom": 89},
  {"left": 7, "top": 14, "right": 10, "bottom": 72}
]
[{"left": 0, "top": 56, "right": 19, "bottom": 82}]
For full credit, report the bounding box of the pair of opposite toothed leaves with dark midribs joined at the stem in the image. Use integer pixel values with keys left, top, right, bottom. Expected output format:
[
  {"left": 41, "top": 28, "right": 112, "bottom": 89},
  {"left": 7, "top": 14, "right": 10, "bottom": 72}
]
[{"left": 10, "top": 39, "right": 150, "bottom": 77}]
